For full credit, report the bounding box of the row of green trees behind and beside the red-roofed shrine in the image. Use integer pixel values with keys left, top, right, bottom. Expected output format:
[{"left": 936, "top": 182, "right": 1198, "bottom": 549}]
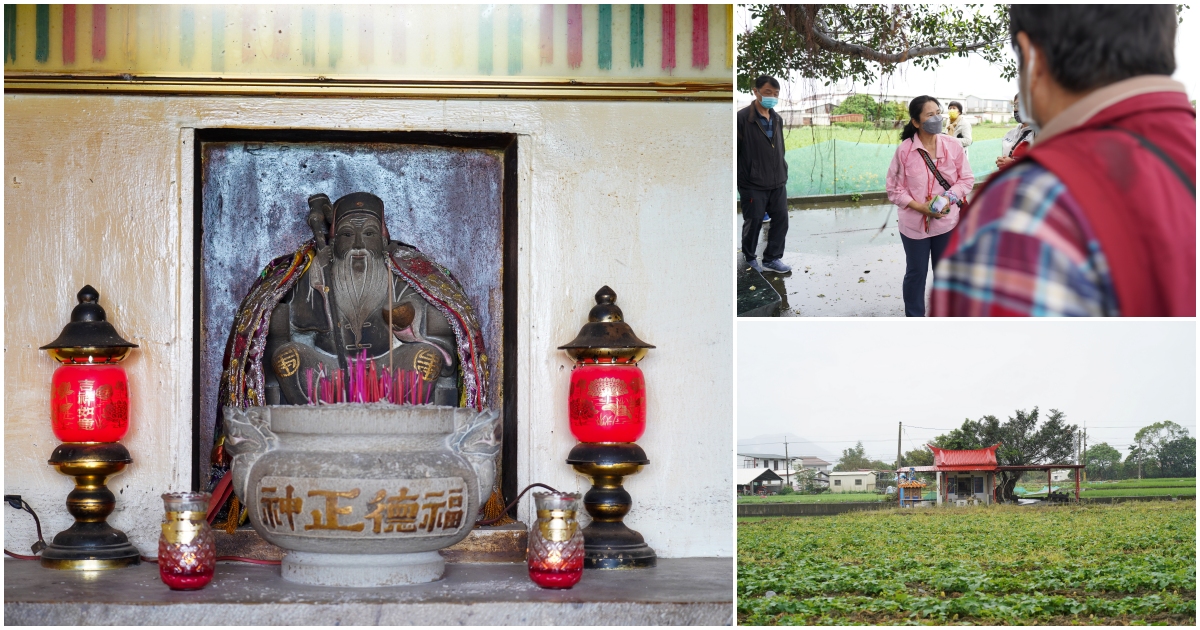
[{"left": 834, "top": 407, "right": 1196, "bottom": 500}]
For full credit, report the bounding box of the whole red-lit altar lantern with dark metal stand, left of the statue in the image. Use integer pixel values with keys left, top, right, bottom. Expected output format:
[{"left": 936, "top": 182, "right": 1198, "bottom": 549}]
[{"left": 41, "top": 284, "right": 140, "bottom": 570}]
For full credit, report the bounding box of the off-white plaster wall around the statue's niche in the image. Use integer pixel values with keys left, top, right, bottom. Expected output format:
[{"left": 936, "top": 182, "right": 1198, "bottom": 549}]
[{"left": 4, "top": 95, "right": 733, "bottom": 557}]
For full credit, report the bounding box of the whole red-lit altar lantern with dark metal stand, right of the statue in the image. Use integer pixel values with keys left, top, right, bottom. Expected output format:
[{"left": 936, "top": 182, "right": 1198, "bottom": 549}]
[{"left": 559, "top": 287, "right": 658, "bottom": 569}]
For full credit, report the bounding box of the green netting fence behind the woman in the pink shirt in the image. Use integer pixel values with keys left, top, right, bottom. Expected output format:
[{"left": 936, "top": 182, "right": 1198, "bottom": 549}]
[{"left": 786, "top": 127, "right": 1001, "bottom": 197}]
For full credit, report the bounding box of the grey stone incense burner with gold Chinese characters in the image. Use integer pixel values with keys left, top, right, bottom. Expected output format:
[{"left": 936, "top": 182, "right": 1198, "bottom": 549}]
[{"left": 224, "top": 403, "right": 500, "bottom": 587}]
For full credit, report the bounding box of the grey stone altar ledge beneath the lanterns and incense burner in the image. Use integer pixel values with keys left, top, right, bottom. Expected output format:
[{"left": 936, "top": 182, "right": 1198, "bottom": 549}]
[{"left": 4, "top": 558, "right": 733, "bottom": 625}]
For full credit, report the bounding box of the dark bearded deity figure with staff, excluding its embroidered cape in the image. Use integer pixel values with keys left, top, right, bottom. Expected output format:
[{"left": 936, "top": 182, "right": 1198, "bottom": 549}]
[{"left": 265, "top": 192, "right": 461, "bottom": 406}]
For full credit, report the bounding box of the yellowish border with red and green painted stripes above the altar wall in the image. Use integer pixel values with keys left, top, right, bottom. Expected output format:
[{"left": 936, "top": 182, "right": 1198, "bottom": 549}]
[{"left": 5, "top": 5, "right": 733, "bottom": 100}]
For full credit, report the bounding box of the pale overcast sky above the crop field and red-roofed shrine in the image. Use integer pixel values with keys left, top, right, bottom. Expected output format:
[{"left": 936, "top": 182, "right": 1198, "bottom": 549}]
[{"left": 737, "top": 319, "right": 1196, "bottom": 462}]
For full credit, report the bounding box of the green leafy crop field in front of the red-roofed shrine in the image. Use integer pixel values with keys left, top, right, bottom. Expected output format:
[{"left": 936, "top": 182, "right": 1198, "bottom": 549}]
[{"left": 737, "top": 500, "right": 1196, "bottom": 625}]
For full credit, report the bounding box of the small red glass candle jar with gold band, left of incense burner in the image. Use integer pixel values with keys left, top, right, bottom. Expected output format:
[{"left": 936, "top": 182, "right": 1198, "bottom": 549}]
[{"left": 158, "top": 492, "right": 217, "bottom": 590}]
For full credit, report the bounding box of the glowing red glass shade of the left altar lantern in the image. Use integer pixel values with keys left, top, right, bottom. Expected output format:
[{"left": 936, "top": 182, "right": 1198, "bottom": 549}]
[{"left": 50, "top": 362, "right": 130, "bottom": 442}]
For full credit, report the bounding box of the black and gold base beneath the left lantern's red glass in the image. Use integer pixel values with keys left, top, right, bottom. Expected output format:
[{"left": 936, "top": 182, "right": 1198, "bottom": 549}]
[{"left": 42, "top": 442, "right": 140, "bottom": 571}]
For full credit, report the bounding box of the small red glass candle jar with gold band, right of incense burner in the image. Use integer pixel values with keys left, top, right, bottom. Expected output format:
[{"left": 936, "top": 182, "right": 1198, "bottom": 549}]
[{"left": 528, "top": 492, "right": 583, "bottom": 588}]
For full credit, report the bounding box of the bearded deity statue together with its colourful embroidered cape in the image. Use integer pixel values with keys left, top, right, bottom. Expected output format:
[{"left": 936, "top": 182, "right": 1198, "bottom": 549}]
[{"left": 214, "top": 192, "right": 503, "bottom": 530}]
